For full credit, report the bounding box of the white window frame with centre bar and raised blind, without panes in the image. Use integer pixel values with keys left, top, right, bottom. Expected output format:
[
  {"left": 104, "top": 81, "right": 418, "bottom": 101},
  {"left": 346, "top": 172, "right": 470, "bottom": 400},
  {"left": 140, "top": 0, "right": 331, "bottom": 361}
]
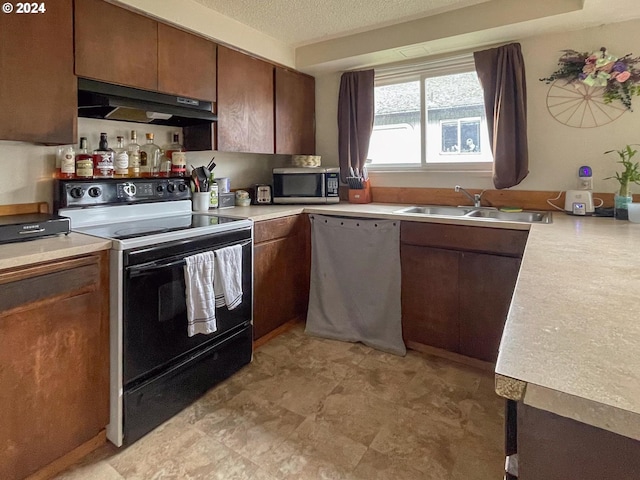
[{"left": 367, "top": 53, "right": 493, "bottom": 172}]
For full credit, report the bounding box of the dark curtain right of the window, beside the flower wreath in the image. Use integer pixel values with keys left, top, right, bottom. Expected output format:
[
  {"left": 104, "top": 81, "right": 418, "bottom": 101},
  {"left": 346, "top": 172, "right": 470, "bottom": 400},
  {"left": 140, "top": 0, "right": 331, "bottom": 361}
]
[{"left": 473, "top": 43, "right": 529, "bottom": 188}]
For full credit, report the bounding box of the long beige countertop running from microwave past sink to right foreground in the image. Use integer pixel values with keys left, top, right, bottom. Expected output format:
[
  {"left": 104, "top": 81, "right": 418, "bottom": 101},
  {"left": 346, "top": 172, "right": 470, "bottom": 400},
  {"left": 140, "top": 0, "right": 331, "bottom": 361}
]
[{"left": 219, "top": 203, "right": 640, "bottom": 440}]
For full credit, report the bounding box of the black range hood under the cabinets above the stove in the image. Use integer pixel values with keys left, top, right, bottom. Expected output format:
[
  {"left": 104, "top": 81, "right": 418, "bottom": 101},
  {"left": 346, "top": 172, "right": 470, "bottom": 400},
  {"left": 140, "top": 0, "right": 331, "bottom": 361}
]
[{"left": 78, "top": 78, "right": 218, "bottom": 127}]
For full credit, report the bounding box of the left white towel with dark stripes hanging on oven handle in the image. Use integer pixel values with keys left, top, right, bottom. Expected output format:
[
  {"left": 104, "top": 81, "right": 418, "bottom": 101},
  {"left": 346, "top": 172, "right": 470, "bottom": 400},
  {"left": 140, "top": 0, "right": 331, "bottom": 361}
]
[{"left": 184, "top": 252, "right": 218, "bottom": 337}]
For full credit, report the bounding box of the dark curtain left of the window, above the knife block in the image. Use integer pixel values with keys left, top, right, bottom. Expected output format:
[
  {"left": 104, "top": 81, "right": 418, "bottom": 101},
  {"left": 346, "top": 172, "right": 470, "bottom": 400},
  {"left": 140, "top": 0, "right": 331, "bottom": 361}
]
[{"left": 338, "top": 70, "right": 374, "bottom": 182}]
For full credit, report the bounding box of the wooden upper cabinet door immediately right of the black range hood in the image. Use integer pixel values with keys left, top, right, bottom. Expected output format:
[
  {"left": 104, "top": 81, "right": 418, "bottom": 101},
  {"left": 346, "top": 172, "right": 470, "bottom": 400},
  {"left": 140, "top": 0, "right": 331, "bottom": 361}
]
[{"left": 217, "top": 46, "right": 274, "bottom": 153}]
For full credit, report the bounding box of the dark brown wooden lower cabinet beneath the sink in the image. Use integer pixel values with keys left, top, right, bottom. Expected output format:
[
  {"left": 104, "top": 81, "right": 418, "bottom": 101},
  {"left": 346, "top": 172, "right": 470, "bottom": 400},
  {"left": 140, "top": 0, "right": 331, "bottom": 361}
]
[{"left": 400, "top": 222, "right": 527, "bottom": 362}]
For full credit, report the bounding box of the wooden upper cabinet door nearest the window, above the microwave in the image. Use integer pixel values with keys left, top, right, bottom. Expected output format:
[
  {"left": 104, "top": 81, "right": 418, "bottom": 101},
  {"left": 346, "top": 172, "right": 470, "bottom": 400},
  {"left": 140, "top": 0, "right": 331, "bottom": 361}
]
[{"left": 275, "top": 67, "right": 316, "bottom": 155}]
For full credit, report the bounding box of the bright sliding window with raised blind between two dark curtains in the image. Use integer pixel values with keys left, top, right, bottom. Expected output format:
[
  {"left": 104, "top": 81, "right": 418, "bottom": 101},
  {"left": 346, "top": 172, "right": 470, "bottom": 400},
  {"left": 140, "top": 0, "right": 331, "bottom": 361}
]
[{"left": 368, "top": 56, "right": 493, "bottom": 170}]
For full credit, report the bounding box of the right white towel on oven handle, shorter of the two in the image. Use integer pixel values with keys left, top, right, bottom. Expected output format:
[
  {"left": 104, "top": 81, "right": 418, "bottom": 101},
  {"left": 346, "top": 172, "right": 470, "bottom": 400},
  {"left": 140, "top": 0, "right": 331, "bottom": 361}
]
[{"left": 213, "top": 245, "right": 242, "bottom": 310}]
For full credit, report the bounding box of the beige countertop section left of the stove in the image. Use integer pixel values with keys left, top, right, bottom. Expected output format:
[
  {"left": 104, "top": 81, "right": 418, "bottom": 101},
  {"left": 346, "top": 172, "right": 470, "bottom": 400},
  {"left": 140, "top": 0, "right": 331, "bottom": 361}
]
[{"left": 0, "top": 232, "right": 111, "bottom": 270}]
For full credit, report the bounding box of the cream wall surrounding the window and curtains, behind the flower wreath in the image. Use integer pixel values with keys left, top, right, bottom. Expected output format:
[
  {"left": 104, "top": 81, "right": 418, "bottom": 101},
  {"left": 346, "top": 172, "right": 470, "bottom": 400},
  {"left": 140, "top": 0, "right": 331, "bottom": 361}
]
[{"left": 316, "top": 20, "right": 640, "bottom": 192}]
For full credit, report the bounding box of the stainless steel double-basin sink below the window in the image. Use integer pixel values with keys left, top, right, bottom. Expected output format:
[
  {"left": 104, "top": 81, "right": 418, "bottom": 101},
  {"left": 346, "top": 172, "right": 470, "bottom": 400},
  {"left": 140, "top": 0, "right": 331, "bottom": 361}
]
[{"left": 393, "top": 205, "right": 552, "bottom": 223}]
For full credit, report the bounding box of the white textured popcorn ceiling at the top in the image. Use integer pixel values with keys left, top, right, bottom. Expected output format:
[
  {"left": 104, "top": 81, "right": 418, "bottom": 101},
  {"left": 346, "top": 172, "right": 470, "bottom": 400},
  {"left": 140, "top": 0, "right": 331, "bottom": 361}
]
[{"left": 194, "top": 0, "right": 488, "bottom": 46}]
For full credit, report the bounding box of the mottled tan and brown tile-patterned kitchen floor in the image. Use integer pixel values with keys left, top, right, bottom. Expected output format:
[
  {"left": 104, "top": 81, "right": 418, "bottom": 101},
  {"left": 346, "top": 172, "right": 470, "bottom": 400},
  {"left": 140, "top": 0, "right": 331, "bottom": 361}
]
[{"left": 56, "top": 326, "right": 504, "bottom": 480}]
